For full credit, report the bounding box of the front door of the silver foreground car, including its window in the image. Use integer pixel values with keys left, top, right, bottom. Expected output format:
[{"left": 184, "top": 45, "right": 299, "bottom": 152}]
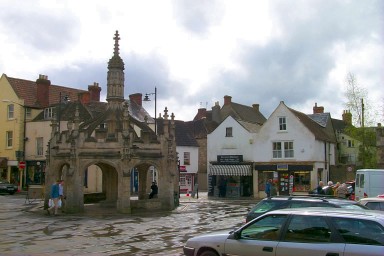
[{"left": 224, "top": 214, "right": 288, "bottom": 256}]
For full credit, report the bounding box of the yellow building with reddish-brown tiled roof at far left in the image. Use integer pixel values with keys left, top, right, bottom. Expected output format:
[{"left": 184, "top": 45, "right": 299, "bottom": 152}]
[{"left": 0, "top": 74, "right": 89, "bottom": 189}]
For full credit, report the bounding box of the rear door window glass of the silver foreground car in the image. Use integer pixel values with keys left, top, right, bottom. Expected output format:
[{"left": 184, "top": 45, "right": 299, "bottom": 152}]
[{"left": 283, "top": 215, "right": 331, "bottom": 243}]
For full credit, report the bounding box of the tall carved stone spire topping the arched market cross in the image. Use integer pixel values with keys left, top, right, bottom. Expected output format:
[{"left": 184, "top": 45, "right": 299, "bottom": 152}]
[{"left": 107, "top": 30, "right": 124, "bottom": 108}]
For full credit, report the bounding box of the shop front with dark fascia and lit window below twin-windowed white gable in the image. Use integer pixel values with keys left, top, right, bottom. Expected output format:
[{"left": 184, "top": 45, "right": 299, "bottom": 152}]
[{"left": 254, "top": 164, "right": 314, "bottom": 197}]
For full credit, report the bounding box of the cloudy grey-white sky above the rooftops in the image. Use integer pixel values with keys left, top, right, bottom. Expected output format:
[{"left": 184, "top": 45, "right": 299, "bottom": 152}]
[{"left": 0, "top": 0, "right": 384, "bottom": 122}]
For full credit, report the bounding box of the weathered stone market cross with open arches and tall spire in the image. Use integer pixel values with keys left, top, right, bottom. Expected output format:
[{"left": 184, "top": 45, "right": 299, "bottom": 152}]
[{"left": 45, "top": 31, "right": 178, "bottom": 213}]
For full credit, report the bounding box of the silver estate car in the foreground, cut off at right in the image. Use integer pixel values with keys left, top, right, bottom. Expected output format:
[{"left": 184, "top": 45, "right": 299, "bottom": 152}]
[{"left": 183, "top": 207, "right": 384, "bottom": 256}]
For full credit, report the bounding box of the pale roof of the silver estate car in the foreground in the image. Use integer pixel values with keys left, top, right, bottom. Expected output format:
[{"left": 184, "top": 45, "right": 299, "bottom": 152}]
[{"left": 265, "top": 207, "right": 384, "bottom": 218}]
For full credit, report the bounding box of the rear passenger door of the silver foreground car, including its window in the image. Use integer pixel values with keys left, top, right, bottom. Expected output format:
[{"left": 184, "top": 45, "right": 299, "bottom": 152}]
[{"left": 276, "top": 214, "right": 345, "bottom": 256}]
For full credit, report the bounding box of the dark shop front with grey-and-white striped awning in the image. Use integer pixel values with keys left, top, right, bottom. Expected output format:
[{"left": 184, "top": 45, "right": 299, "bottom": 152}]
[{"left": 208, "top": 155, "right": 253, "bottom": 198}]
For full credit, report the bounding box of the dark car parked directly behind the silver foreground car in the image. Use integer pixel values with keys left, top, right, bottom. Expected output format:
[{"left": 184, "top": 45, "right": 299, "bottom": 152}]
[{"left": 245, "top": 196, "right": 368, "bottom": 222}]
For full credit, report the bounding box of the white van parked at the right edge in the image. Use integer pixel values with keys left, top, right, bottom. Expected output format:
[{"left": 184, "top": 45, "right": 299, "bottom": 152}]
[{"left": 355, "top": 169, "right": 384, "bottom": 201}]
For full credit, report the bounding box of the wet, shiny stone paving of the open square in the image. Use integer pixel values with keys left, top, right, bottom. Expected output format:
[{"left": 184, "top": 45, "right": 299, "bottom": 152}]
[{"left": 0, "top": 193, "right": 256, "bottom": 255}]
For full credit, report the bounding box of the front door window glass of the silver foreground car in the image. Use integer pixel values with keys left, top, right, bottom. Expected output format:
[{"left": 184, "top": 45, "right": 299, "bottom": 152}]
[{"left": 240, "top": 214, "right": 287, "bottom": 241}]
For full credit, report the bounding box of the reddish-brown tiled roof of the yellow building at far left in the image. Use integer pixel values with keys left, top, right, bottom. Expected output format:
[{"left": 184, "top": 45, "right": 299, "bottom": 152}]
[{"left": 7, "top": 76, "right": 87, "bottom": 108}]
